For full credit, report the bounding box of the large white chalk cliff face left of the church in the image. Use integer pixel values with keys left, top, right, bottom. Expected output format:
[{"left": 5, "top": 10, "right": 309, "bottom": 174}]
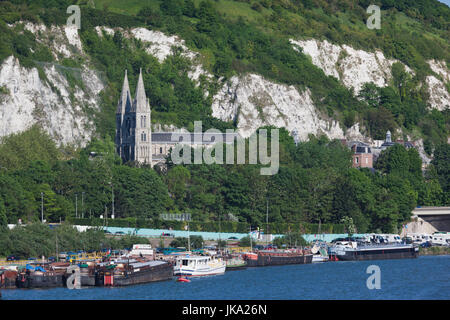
[{"left": 0, "top": 56, "right": 103, "bottom": 146}]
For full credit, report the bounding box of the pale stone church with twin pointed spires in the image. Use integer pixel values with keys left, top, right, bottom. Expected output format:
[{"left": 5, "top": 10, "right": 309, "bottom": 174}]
[{"left": 114, "top": 69, "right": 237, "bottom": 167}]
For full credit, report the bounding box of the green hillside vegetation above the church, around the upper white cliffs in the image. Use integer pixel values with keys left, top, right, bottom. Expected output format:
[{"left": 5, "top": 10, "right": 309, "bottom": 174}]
[{"left": 0, "top": 0, "right": 450, "bottom": 146}]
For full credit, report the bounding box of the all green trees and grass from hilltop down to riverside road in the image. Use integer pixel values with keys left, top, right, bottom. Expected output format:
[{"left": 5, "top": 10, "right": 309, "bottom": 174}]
[{"left": 0, "top": 0, "right": 450, "bottom": 240}]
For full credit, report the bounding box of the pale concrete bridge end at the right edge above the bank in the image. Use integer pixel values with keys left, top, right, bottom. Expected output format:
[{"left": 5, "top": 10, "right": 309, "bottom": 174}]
[{"left": 402, "top": 207, "right": 450, "bottom": 234}]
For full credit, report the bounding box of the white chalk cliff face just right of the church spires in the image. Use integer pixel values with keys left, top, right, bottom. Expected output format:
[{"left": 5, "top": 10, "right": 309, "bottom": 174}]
[{"left": 212, "top": 74, "right": 344, "bottom": 141}]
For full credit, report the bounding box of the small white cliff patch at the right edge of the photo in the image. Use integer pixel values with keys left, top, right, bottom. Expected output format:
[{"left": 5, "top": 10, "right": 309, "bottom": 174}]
[{"left": 425, "top": 60, "right": 450, "bottom": 111}]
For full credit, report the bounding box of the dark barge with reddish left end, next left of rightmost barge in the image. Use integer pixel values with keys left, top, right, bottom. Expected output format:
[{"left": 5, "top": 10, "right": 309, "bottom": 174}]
[{"left": 244, "top": 250, "right": 313, "bottom": 267}]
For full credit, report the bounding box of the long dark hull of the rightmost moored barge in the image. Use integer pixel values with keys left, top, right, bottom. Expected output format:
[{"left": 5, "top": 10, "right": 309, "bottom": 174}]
[{"left": 336, "top": 247, "right": 419, "bottom": 261}]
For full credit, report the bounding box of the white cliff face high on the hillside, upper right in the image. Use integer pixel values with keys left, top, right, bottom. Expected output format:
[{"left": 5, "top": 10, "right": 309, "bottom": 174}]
[{"left": 291, "top": 39, "right": 412, "bottom": 94}]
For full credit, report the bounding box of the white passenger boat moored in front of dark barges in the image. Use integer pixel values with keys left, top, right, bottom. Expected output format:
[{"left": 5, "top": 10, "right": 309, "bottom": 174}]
[{"left": 173, "top": 255, "right": 226, "bottom": 277}]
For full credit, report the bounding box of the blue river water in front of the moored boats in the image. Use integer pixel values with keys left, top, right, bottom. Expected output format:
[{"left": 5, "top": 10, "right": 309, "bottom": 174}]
[{"left": 2, "top": 256, "right": 450, "bottom": 300}]
